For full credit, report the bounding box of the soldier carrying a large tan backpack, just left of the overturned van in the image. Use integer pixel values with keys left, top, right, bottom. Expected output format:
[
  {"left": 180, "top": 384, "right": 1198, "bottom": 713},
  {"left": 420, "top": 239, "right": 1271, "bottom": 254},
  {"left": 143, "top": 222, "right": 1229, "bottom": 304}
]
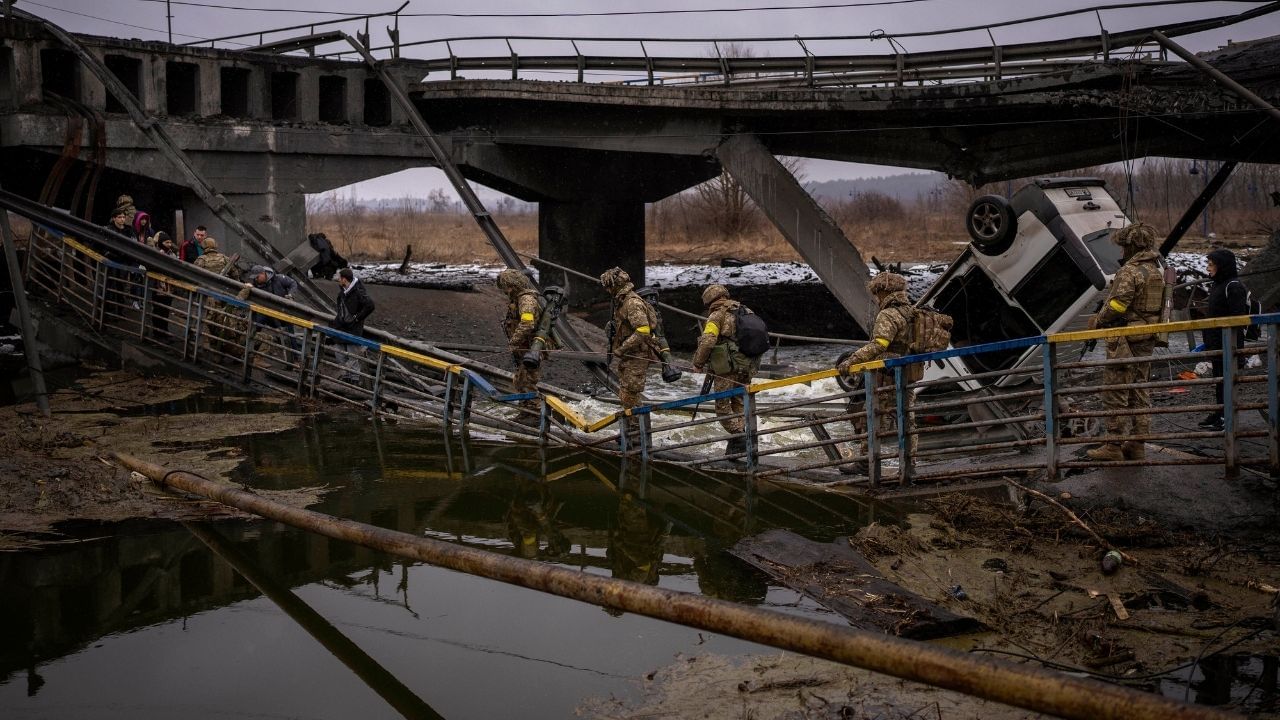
[{"left": 836, "top": 273, "right": 924, "bottom": 475}]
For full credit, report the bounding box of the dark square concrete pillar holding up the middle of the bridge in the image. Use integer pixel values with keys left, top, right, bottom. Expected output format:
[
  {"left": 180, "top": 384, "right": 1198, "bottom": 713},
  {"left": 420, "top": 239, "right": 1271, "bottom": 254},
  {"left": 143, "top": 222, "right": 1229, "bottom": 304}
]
[{"left": 538, "top": 201, "right": 644, "bottom": 307}]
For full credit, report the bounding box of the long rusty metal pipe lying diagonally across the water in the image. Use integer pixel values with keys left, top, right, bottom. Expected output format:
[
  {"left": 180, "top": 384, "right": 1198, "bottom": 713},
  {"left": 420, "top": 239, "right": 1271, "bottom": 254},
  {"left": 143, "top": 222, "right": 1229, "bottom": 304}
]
[{"left": 115, "top": 454, "right": 1228, "bottom": 720}]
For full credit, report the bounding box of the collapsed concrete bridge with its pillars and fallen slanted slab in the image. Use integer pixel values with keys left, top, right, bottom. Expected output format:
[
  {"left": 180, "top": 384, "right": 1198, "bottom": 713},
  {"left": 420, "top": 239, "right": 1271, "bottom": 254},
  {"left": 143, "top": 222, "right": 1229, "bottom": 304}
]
[{"left": 0, "top": 3, "right": 1280, "bottom": 323}]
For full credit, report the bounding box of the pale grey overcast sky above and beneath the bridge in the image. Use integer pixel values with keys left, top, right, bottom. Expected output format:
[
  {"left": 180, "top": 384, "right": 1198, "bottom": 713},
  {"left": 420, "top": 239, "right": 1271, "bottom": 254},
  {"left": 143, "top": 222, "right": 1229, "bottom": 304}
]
[{"left": 18, "top": 0, "right": 1280, "bottom": 197}]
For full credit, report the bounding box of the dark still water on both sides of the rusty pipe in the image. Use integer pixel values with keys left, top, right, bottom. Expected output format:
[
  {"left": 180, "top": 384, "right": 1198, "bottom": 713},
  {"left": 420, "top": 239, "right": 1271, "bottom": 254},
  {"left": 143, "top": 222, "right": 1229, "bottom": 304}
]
[{"left": 0, "top": 416, "right": 896, "bottom": 719}]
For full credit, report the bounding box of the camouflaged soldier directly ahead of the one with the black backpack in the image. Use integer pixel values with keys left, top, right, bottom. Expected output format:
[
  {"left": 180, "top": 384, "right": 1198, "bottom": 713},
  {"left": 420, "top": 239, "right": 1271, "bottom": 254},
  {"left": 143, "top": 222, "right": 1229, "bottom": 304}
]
[{"left": 600, "top": 268, "right": 658, "bottom": 430}]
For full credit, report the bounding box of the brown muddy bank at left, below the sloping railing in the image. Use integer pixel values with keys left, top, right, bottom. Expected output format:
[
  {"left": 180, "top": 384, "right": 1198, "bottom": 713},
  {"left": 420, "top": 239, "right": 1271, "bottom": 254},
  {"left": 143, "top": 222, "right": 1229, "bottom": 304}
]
[{"left": 0, "top": 370, "right": 325, "bottom": 550}]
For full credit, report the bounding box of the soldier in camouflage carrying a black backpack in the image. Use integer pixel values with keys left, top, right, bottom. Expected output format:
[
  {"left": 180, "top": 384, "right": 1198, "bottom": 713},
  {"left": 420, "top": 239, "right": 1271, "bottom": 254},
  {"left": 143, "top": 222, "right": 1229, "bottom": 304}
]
[{"left": 694, "top": 284, "right": 760, "bottom": 455}]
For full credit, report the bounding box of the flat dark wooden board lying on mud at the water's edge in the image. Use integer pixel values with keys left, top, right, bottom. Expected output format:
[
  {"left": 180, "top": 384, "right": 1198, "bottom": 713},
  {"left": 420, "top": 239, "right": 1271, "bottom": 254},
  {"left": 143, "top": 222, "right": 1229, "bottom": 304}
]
[{"left": 730, "top": 530, "right": 983, "bottom": 638}]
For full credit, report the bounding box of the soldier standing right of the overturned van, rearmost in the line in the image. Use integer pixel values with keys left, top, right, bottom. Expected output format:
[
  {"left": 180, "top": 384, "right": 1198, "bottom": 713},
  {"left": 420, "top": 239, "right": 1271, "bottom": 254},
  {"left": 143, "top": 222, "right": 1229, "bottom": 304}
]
[{"left": 1087, "top": 223, "right": 1165, "bottom": 460}]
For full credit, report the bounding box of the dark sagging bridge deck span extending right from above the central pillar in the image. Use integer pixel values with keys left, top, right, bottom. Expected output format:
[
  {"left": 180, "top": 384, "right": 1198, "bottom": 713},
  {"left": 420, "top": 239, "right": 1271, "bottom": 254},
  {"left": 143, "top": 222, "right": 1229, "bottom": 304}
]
[{"left": 416, "top": 37, "right": 1280, "bottom": 184}]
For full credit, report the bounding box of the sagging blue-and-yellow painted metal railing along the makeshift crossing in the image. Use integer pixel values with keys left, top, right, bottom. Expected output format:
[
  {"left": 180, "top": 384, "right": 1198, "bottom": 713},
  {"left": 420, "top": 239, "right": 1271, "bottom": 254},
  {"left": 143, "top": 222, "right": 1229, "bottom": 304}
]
[{"left": 12, "top": 199, "right": 1280, "bottom": 487}]
